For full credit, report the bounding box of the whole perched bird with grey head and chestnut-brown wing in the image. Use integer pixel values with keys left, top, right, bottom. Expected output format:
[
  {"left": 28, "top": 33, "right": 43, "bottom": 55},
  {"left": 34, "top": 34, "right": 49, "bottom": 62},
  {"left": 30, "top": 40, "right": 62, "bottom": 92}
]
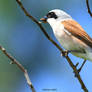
[{"left": 41, "top": 9, "right": 92, "bottom": 61}]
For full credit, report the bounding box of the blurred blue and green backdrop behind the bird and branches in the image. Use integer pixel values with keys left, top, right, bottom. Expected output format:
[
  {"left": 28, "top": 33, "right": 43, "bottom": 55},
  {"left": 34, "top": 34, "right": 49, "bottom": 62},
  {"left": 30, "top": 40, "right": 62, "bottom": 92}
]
[{"left": 0, "top": 0, "right": 92, "bottom": 92}]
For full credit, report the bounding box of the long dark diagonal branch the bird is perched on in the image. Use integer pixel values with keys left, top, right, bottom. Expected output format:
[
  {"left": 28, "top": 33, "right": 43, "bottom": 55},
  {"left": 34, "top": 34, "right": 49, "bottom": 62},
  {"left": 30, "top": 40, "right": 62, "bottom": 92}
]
[{"left": 16, "top": 0, "right": 88, "bottom": 92}]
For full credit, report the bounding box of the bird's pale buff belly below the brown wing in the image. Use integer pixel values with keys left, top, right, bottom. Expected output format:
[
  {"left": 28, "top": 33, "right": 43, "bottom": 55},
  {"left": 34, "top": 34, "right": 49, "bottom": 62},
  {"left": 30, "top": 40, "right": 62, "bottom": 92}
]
[{"left": 54, "top": 31, "right": 92, "bottom": 61}]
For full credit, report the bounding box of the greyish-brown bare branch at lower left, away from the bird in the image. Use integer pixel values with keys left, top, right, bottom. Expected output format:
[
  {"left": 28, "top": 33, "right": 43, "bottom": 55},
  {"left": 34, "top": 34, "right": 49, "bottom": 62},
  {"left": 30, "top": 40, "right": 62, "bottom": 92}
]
[{"left": 0, "top": 46, "right": 36, "bottom": 92}]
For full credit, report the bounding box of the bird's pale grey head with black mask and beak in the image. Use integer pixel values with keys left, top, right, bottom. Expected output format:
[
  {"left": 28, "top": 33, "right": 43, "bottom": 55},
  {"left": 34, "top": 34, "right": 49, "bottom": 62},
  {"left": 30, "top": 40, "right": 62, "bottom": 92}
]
[{"left": 41, "top": 9, "right": 72, "bottom": 23}]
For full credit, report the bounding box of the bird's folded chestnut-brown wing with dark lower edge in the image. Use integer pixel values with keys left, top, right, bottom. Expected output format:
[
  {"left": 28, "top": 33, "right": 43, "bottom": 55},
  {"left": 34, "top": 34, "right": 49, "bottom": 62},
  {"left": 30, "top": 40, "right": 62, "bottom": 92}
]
[{"left": 62, "top": 20, "right": 92, "bottom": 48}]
